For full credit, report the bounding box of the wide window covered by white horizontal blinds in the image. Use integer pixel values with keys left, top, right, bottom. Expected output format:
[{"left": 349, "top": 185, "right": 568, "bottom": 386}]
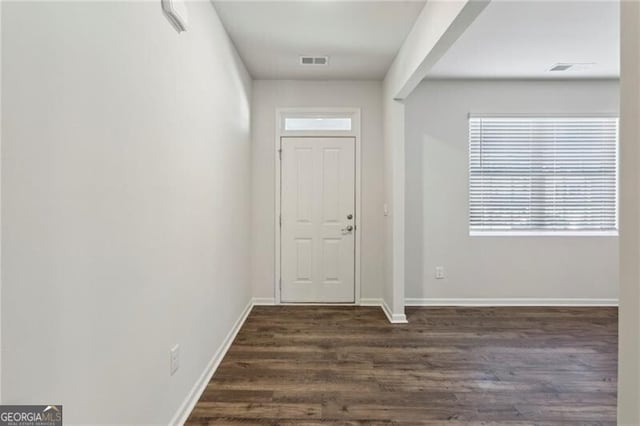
[{"left": 469, "top": 116, "right": 618, "bottom": 235}]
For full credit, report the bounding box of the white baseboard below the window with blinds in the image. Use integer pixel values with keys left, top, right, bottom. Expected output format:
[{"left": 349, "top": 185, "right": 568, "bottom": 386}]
[{"left": 405, "top": 298, "right": 618, "bottom": 307}]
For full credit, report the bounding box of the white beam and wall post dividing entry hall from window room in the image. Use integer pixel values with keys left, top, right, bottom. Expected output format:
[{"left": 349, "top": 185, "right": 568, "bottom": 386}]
[{"left": 382, "top": 0, "right": 489, "bottom": 323}]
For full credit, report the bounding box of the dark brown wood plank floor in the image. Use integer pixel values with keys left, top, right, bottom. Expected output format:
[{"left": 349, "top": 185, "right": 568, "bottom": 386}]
[{"left": 187, "top": 306, "right": 618, "bottom": 425}]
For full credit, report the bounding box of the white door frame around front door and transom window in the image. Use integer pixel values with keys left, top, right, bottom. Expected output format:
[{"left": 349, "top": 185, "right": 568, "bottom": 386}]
[{"left": 273, "top": 108, "right": 362, "bottom": 305}]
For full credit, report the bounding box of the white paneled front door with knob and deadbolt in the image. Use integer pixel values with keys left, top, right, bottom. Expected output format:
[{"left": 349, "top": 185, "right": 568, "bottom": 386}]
[{"left": 280, "top": 137, "right": 356, "bottom": 302}]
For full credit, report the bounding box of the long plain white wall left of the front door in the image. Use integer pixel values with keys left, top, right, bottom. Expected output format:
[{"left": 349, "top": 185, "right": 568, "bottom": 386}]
[{"left": 2, "top": 2, "right": 251, "bottom": 424}]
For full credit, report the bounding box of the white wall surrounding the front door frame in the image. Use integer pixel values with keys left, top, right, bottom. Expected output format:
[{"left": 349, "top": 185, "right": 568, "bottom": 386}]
[{"left": 251, "top": 80, "right": 384, "bottom": 299}]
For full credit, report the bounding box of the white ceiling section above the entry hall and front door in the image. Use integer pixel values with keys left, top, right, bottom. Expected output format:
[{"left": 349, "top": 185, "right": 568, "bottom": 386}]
[{"left": 213, "top": 0, "right": 424, "bottom": 80}]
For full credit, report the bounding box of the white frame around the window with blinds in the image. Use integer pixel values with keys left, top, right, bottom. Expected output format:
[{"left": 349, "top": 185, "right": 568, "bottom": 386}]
[{"left": 467, "top": 113, "right": 620, "bottom": 237}]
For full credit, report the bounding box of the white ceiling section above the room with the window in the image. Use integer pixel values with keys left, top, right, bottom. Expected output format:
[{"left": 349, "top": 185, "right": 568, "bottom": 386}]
[{"left": 428, "top": 0, "right": 620, "bottom": 79}]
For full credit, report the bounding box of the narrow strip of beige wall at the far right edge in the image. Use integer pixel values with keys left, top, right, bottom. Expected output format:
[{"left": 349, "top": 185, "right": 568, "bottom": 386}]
[{"left": 618, "top": 1, "right": 640, "bottom": 425}]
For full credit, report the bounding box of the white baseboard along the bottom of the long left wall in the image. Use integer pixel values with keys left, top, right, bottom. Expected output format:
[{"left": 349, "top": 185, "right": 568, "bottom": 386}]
[{"left": 169, "top": 299, "right": 254, "bottom": 425}]
